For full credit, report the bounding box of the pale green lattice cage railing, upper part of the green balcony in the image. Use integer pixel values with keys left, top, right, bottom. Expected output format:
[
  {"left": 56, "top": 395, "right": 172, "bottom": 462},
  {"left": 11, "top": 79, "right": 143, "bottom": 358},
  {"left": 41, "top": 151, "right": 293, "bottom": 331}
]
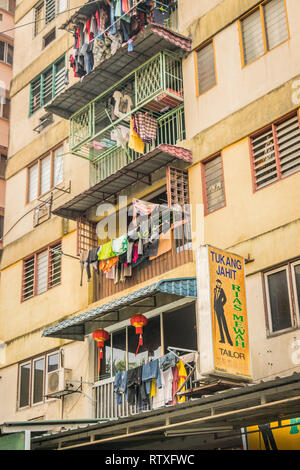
[{"left": 70, "top": 51, "right": 183, "bottom": 161}]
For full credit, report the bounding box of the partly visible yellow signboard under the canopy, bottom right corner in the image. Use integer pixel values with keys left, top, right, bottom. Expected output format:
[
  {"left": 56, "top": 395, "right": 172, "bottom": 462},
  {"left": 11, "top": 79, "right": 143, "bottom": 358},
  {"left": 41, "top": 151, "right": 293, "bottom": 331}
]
[{"left": 247, "top": 418, "right": 300, "bottom": 450}]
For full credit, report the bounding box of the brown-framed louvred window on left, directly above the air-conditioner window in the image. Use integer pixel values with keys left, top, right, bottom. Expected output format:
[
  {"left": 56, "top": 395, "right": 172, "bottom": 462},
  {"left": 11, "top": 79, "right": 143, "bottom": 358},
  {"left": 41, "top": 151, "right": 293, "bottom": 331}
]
[{"left": 22, "top": 242, "right": 61, "bottom": 301}]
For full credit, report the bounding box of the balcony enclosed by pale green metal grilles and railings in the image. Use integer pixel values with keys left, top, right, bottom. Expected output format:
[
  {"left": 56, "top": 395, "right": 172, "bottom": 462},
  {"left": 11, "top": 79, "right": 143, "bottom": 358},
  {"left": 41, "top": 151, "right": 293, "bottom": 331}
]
[{"left": 70, "top": 52, "right": 184, "bottom": 159}]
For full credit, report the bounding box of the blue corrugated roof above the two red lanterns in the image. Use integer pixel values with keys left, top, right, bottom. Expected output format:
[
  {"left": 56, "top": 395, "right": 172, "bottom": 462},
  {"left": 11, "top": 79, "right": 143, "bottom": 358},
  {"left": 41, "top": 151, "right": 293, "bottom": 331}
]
[{"left": 42, "top": 277, "right": 197, "bottom": 341}]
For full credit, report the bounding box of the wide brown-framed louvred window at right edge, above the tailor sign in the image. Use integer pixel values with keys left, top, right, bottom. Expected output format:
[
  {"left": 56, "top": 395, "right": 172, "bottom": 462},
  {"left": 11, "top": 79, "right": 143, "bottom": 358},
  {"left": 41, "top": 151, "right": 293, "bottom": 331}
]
[{"left": 250, "top": 113, "right": 300, "bottom": 190}]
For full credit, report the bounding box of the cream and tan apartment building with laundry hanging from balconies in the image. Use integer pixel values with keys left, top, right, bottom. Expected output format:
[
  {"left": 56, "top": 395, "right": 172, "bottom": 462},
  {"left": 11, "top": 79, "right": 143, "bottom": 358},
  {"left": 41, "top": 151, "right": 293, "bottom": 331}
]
[{"left": 0, "top": 0, "right": 300, "bottom": 449}]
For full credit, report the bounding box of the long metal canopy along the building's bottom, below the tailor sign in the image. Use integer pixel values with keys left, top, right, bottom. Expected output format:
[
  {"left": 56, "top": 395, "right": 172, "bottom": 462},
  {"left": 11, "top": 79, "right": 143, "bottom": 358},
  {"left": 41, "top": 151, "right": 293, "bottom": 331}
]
[{"left": 32, "top": 373, "right": 300, "bottom": 450}]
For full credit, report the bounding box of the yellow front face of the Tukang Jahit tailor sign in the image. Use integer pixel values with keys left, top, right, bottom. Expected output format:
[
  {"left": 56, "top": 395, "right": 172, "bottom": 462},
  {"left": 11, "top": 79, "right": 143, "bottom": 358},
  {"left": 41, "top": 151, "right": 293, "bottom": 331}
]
[{"left": 208, "top": 247, "right": 251, "bottom": 379}]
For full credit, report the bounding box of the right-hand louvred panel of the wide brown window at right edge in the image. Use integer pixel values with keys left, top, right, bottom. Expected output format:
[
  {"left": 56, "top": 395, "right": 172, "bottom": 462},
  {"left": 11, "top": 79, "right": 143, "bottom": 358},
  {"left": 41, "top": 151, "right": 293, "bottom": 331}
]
[{"left": 276, "top": 114, "right": 300, "bottom": 176}]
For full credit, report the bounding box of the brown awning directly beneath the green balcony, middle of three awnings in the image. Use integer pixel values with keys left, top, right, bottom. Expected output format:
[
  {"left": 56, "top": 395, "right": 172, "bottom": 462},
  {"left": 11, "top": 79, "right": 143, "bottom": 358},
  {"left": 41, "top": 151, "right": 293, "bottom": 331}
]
[{"left": 52, "top": 144, "right": 192, "bottom": 220}]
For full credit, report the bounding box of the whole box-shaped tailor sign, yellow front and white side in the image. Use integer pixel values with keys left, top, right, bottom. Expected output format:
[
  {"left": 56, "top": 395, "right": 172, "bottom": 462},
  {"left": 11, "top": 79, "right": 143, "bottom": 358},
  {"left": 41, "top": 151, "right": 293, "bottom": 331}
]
[{"left": 197, "top": 246, "right": 251, "bottom": 380}]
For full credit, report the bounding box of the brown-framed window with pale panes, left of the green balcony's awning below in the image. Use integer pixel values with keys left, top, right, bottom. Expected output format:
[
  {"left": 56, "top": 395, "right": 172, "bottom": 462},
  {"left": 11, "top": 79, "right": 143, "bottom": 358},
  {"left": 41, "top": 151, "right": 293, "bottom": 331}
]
[{"left": 27, "top": 145, "right": 64, "bottom": 202}]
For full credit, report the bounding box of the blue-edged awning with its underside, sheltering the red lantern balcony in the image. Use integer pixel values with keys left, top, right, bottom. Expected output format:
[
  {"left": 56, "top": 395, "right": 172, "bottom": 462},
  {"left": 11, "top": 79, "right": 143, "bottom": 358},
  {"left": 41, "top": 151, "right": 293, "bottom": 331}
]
[{"left": 42, "top": 277, "right": 197, "bottom": 341}]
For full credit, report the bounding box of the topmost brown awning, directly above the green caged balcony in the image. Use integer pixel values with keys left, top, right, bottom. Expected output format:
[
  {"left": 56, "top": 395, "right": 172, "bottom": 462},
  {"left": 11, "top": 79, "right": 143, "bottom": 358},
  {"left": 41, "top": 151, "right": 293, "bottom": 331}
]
[{"left": 45, "top": 24, "right": 191, "bottom": 119}]
